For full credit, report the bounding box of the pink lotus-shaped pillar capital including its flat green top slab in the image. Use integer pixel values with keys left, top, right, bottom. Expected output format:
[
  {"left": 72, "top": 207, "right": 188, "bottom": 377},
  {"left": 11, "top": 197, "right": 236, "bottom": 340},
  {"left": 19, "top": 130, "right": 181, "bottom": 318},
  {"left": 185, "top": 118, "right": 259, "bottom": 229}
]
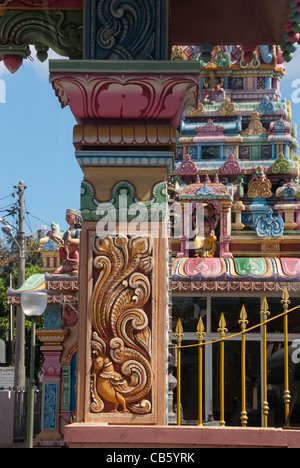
[{"left": 50, "top": 61, "right": 198, "bottom": 127}]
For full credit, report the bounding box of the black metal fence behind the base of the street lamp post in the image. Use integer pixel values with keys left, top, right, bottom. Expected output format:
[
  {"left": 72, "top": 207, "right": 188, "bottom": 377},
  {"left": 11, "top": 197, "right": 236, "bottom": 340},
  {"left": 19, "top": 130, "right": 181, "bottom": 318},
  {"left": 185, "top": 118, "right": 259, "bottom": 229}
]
[{"left": 14, "top": 389, "right": 42, "bottom": 442}]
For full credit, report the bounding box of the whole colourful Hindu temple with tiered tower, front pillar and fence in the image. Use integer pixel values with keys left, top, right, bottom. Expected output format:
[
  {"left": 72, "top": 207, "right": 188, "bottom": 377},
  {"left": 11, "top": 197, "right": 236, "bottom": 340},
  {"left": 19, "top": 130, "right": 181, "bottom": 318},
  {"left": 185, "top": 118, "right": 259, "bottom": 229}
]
[{"left": 0, "top": 0, "right": 300, "bottom": 447}]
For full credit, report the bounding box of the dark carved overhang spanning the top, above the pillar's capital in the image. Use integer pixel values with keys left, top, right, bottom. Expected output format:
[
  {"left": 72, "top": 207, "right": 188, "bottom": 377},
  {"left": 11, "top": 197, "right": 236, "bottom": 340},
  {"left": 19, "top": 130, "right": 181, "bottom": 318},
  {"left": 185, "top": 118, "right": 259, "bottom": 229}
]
[{"left": 0, "top": 0, "right": 300, "bottom": 73}]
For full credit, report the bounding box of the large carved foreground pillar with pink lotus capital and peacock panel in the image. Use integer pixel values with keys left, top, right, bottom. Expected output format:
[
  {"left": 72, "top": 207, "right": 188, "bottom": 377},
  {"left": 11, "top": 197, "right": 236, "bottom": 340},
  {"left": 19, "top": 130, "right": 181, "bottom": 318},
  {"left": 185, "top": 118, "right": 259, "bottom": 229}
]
[{"left": 50, "top": 62, "right": 198, "bottom": 432}]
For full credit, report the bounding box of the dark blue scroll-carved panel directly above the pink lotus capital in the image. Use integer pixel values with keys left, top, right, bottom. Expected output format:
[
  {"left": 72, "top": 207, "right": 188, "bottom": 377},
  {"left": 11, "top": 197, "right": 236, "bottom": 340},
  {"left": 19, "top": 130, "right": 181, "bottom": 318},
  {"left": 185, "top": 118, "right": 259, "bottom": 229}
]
[{"left": 86, "top": 0, "right": 167, "bottom": 60}]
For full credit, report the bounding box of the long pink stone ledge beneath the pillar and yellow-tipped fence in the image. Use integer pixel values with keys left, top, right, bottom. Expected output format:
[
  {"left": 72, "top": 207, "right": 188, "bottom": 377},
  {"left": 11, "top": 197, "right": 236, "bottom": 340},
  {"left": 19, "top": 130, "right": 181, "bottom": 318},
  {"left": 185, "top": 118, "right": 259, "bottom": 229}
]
[{"left": 65, "top": 423, "right": 300, "bottom": 449}]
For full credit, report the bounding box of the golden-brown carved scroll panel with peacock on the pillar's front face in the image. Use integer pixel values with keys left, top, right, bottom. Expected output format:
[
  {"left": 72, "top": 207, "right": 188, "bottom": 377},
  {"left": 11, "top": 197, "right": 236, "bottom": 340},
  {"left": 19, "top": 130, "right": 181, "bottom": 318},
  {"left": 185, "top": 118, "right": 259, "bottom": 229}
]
[{"left": 90, "top": 236, "right": 153, "bottom": 414}]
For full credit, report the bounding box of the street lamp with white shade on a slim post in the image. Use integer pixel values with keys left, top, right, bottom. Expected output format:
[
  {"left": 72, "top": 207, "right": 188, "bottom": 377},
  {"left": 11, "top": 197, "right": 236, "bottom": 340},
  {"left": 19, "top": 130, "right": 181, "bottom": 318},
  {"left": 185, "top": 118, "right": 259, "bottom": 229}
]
[{"left": 21, "top": 292, "right": 47, "bottom": 448}]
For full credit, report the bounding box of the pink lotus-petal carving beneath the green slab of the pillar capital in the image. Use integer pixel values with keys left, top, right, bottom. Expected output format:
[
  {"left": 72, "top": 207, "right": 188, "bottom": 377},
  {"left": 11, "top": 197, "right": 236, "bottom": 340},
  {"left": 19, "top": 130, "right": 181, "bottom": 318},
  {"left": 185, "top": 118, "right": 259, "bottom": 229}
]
[{"left": 51, "top": 72, "right": 197, "bottom": 127}]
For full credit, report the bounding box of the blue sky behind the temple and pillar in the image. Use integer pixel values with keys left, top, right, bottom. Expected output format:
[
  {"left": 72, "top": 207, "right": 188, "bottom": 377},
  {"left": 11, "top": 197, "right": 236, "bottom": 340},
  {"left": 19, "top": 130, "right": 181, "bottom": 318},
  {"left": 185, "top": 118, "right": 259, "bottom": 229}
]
[{"left": 0, "top": 47, "right": 300, "bottom": 235}]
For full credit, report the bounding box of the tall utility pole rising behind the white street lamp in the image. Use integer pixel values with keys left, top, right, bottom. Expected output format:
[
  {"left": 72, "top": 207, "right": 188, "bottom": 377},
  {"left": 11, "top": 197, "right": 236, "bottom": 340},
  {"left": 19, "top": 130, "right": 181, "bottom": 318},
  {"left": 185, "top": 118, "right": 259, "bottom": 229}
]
[{"left": 14, "top": 181, "right": 27, "bottom": 390}]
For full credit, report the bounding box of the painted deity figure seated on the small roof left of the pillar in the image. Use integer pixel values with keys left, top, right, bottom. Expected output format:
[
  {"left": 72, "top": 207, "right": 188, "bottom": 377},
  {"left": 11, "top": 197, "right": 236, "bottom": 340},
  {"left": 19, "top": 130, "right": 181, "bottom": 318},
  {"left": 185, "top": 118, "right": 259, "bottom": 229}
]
[{"left": 47, "top": 209, "right": 82, "bottom": 276}]
